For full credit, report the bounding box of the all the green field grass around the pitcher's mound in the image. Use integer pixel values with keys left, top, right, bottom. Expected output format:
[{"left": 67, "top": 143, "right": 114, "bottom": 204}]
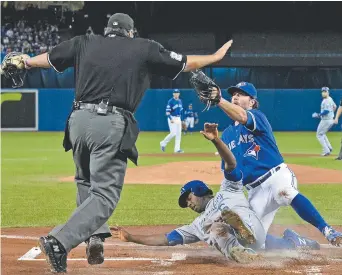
[{"left": 1, "top": 132, "right": 342, "bottom": 227}]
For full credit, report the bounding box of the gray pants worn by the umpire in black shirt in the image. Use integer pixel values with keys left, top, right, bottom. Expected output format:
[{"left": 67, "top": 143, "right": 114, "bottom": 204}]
[{"left": 49, "top": 110, "right": 127, "bottom": 252}]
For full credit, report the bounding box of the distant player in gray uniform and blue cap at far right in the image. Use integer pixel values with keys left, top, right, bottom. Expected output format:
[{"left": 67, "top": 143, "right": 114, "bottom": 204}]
[{"left": 312, "top": 87, "right": 336, "bottom": 157}]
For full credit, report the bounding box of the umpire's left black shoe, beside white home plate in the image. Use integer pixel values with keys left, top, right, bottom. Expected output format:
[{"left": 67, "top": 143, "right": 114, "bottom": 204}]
[{"left": 39, "top": 236, "right": 67, "bottom": 273}]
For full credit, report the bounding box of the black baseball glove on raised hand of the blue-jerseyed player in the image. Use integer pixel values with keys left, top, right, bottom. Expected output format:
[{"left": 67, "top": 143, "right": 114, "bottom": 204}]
[{"left": 190, "top": 70, "right": 221, "bottom": 111}]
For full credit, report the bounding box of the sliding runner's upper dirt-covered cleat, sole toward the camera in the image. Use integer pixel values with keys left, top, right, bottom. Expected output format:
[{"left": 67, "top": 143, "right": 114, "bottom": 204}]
[{"left": 221, "top": 209, "right": 256, "bottom": 244}]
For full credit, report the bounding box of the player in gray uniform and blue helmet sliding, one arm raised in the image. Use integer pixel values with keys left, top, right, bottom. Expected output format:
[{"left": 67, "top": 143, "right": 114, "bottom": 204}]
[{"left": 114, "top": 123, "right": 266, "bottom": 263}]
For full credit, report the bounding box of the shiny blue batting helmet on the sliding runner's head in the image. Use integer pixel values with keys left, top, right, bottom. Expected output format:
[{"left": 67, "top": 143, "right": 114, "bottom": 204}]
[{"left": 178, "top": 180, "right": 213, "bottom": 208}]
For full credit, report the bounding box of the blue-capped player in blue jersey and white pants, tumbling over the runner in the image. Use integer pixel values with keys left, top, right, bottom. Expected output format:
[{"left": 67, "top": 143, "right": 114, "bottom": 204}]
[{"left": 211, "top": 82, "right": 342, "bottom": 246}]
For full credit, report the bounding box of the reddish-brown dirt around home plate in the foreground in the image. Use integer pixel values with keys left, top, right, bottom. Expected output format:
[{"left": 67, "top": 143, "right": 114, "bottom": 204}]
[{"left": 1, "top": 225, "right": 342, "bottom": 275}]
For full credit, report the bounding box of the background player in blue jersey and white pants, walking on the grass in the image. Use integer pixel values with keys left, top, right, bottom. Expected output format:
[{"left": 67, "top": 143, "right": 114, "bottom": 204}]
[{"left": 160, "top": 89, "right": 184, "bottom": 153}]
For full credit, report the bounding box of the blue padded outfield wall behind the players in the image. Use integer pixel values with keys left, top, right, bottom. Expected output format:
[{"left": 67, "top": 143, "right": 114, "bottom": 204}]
[{"left": 2, "top": 89, "right": 342, "bottom": 131}]
